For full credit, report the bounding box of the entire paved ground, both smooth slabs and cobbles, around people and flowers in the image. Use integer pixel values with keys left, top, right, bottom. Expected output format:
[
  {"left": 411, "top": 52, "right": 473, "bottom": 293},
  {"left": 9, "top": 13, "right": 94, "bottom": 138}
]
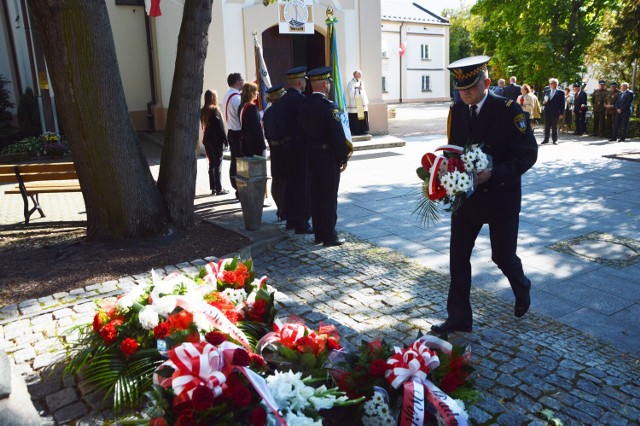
[{"left": 0, "top": 105, "right": 640, "bottom": 425}]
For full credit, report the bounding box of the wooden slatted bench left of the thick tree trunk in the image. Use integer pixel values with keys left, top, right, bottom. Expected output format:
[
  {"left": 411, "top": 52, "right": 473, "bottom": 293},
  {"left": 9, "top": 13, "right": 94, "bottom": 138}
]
[{"left": 0, "top": 162, "right": 80, "bottom": 225}]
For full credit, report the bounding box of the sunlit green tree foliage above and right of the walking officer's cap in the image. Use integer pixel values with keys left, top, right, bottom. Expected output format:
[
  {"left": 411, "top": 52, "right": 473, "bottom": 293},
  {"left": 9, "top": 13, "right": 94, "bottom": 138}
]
[{"left": 471, "top": 0, "right": 616, "bottom": 87}]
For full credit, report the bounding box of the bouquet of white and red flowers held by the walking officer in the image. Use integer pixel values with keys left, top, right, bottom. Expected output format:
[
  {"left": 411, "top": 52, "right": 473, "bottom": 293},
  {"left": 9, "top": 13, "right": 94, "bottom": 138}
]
[{"left": 416, "top": 144, "right": 491, "bottom": 225}]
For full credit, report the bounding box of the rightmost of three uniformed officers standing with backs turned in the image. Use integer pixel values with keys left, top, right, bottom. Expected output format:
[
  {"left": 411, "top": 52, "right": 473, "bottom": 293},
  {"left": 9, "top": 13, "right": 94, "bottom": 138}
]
[{"left": 298, "top": 67, "right": 348, "bottom": 247}]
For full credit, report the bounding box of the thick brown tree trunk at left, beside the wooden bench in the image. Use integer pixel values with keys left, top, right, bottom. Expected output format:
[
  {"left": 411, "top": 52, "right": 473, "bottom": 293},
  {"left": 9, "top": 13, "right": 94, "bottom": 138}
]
[{"left": 28, "top": 0, "right": 167, "bottom": 240}]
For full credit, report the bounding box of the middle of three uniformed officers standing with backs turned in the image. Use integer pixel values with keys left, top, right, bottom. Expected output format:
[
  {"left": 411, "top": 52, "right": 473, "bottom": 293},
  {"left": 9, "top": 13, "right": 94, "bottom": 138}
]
[{"left": 278, "top": 67, "right": 313, "bottom": 234}]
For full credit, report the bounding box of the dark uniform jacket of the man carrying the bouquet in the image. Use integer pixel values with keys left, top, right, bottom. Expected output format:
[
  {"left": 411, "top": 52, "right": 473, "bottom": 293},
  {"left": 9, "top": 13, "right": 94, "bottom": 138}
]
[{"left": 449, "top": 93, "right": 538, "bottom": 218}]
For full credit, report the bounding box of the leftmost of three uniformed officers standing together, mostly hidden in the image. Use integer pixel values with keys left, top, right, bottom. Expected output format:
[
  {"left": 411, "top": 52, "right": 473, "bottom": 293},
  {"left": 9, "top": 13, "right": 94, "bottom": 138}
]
[{"left": 262, "top": 84, "right": 288, "bottom": 220}]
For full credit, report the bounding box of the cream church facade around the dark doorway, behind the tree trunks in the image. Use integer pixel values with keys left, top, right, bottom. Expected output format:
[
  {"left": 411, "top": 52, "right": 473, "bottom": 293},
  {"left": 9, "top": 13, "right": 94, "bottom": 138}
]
[{"left": 0, "top": 0, "right": 388, "bottom": 134}]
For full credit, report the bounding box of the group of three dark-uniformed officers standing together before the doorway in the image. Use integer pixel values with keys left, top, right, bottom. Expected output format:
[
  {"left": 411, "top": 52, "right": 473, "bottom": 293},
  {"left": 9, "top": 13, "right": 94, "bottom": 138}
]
[{"left": 263, "top": 67, "right": 348, "bottom": 247}]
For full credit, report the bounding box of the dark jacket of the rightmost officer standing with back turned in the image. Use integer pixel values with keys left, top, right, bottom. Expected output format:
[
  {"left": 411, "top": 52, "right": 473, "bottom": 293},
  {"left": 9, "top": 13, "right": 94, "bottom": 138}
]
[{"left": 298, "top": 93, "right": 347, "bottom": 164}]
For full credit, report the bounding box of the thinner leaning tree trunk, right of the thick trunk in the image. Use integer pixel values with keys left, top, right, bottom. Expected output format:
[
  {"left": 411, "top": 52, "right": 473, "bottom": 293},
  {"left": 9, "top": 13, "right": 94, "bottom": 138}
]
[{"left": 158, "top": 0, "right": 213, "bottom": 229}]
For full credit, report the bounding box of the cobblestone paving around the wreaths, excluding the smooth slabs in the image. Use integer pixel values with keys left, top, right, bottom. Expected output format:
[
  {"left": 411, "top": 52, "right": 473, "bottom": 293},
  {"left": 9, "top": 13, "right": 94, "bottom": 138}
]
[{"left": 0, "top": 234, "right": 640, "bottom": 425}]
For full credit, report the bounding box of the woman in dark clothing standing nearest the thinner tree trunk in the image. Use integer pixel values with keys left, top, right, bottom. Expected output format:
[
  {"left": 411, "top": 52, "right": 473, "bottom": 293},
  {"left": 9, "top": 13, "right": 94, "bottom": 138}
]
[{"left": 200, "top": 90, "right": 229, "bottom": 195}]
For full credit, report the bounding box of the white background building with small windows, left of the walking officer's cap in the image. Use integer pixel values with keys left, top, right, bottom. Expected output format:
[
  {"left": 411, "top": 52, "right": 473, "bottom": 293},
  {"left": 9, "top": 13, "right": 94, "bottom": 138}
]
[{"left": 380, "top": 0, "right": 451, "bottom": 103}]
